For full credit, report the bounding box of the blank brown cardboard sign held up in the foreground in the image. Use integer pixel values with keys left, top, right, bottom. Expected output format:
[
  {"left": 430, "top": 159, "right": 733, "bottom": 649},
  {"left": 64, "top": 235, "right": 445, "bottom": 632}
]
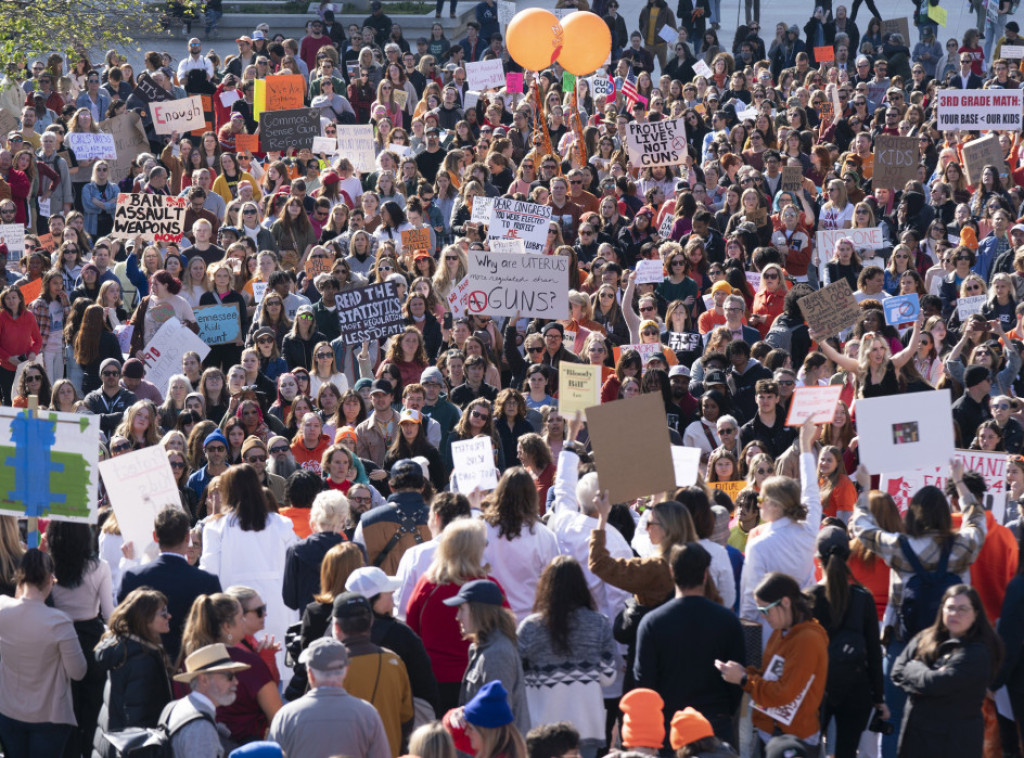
[{"left": 587, "top": 392, "right": 676, "bottom": 503}]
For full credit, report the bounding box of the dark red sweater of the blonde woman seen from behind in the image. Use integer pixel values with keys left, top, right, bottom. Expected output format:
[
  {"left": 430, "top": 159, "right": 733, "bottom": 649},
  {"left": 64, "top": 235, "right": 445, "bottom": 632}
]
[{"left": 406, "top": 576, "right": 509, "bottom": 682}]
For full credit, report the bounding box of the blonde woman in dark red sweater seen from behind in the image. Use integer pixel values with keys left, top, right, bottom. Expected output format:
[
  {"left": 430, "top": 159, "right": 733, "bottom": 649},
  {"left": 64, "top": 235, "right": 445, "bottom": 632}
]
[{"left": 406, "top": 518, "right": 508, "bottom": 711}]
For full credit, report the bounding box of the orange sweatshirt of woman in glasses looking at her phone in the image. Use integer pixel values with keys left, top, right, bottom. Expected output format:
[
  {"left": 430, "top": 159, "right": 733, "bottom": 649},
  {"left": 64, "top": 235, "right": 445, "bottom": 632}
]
[{"left": 743, "top": 619, "right": 828, "bottom": 740}]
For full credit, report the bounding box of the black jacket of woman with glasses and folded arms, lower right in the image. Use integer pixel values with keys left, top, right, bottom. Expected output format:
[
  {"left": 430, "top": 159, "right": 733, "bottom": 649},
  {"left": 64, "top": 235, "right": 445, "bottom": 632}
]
[{"left": 891, "top": 634, "right": 992, "bottom": 758}]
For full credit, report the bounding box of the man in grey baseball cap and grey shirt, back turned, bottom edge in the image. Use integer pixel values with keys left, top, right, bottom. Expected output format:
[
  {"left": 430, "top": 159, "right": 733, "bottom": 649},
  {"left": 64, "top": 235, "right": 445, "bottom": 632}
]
[{"left": 267, "top": 637, "right": 391, "bottom": 758}]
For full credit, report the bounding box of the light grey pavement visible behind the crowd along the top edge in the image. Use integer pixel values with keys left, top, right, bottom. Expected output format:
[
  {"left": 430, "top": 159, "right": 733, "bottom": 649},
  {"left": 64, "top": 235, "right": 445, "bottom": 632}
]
[{"left": 114, "top": 0, "right": 991, "bottom": 77}]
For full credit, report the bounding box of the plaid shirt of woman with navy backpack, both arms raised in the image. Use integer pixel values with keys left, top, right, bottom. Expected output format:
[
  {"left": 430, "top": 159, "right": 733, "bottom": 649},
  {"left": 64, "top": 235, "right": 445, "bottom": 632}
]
[{"left": 850, "top": 491, "right": 985, "bottom": 621}]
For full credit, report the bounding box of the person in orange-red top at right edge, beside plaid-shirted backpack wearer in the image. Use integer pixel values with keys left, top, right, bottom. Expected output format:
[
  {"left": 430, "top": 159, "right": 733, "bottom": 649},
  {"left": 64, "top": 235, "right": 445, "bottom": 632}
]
[{"left": 945, "top": 471, "right": 1019, "bottom": 623}]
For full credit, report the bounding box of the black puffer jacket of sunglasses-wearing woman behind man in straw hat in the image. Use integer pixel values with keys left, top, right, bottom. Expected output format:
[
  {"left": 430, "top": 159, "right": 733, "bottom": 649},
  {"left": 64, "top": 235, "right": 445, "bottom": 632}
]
[{"left": 94, "top": 637, "right": 174, "bottom": 731}]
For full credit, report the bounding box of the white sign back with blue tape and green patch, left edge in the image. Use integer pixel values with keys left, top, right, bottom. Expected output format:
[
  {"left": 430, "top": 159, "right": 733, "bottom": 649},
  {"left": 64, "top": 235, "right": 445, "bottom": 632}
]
[{"left": 0, "top": 405, "right": 99, "bottom": 531}]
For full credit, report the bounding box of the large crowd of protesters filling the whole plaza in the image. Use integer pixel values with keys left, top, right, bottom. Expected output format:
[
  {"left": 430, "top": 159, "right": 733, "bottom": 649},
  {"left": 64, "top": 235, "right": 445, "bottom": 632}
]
[{"left": 0, "top": 0, "right": 1024, "bottom": 758}]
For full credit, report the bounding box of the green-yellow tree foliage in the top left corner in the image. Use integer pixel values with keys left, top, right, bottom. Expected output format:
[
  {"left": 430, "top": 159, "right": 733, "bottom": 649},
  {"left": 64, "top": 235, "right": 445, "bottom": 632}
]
[{"left": 0, "top": 0, "right": 180, "bottom": 66}]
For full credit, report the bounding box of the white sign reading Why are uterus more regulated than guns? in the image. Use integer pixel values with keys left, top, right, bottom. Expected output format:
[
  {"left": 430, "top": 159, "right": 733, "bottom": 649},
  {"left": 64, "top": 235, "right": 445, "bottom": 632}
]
[{"left": 466, "top": 250, "right": 569, "bottom": 319}]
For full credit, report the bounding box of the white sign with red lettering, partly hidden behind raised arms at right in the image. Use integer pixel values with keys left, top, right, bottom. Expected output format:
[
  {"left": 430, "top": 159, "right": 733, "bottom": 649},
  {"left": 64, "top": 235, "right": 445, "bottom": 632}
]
[{"left": 879, "top": 450, "right": 1020, "bottom": 524}]
